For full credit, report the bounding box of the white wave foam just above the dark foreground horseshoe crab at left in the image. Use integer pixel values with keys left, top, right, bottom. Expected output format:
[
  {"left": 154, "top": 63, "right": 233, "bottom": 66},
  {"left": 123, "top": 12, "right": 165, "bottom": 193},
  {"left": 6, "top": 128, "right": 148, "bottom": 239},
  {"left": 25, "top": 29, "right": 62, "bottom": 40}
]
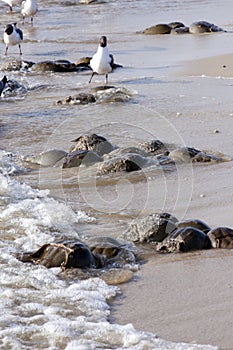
[{"left": 0, "top": 174, "right": 95, "bottom": 249}]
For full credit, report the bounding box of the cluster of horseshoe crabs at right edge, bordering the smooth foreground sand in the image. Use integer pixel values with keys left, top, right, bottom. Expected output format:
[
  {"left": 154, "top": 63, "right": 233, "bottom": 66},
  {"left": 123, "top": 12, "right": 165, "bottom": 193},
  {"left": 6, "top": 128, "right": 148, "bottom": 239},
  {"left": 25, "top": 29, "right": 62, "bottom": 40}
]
[{"left": 122, "top": 213, "right": 233, "bottom": 253}]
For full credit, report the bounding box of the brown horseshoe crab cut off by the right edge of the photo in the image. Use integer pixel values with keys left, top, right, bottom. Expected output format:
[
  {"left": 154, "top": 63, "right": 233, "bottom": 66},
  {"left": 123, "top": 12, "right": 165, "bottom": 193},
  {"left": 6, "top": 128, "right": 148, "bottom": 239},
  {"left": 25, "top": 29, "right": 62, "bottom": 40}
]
[{"left": 208, "top": 227, "right": 233, "bottom": 248}]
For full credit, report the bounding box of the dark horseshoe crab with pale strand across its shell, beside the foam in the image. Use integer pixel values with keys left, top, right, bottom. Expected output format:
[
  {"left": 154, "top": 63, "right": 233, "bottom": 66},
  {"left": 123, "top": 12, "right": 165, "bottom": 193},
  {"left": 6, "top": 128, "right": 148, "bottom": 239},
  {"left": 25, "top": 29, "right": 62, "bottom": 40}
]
[{"left": 16, "top": 242, "right": 97, "bottom": 270}]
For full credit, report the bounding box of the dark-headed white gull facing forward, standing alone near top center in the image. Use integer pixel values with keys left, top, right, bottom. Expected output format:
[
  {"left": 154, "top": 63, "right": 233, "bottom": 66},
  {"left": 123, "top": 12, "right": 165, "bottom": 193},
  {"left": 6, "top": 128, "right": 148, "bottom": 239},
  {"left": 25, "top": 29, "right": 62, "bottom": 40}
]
[{"left": 89, "top": 36, "right": 113, "bottom": 84}]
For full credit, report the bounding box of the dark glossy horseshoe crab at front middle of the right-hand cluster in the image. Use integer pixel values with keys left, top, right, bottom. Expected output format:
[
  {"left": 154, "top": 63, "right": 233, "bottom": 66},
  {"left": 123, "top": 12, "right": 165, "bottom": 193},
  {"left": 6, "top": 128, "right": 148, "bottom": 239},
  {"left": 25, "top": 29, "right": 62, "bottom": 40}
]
[{"left": 156, "top": 227, "right": 211, "bottom": 253}]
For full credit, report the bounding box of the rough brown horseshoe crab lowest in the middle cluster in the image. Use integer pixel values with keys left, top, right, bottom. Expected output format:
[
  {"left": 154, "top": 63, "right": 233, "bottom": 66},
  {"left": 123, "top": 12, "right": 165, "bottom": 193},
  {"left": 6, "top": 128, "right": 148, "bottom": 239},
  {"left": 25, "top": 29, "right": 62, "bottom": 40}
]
[{"left": 98, "top": 153, "right": 147, "bottom": 175}]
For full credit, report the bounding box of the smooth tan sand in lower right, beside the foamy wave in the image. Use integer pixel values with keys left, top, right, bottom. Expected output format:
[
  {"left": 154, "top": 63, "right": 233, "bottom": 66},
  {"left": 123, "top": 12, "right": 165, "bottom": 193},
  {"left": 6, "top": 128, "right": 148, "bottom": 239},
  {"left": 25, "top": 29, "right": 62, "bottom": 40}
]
[{"left": 113, "top": 250, "right": 233, "bottom": 350}]
